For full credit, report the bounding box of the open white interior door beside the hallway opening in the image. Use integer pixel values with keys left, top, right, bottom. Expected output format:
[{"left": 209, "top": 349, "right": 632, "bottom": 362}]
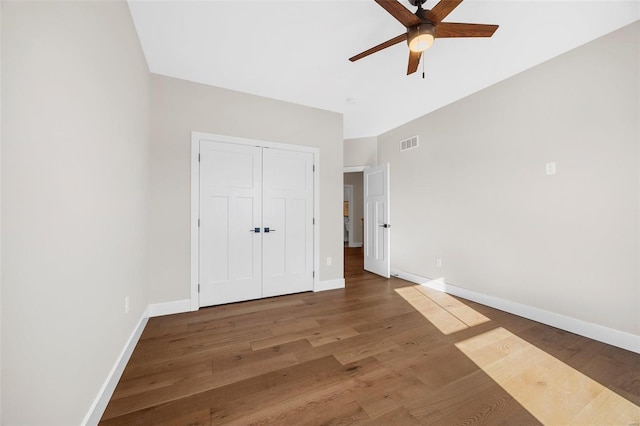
[{"left": 363, "top": 163, "right": 391, "bottom": 278}]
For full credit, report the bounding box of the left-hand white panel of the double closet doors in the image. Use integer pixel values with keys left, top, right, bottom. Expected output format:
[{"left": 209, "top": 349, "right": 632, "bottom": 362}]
[{"left": 199, "top": 141, "right": 262, "bottom": 306}]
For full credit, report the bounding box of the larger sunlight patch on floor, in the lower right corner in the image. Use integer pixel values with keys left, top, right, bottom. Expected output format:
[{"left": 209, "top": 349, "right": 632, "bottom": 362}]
[{"left": 456, "top": 327, "right": 640, "bottom": 426}]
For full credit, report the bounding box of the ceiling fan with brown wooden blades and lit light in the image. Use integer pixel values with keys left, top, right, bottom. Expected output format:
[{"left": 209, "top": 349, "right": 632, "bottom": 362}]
[{"left": 349, "top": 0, "right": 498, "bottom": 75}]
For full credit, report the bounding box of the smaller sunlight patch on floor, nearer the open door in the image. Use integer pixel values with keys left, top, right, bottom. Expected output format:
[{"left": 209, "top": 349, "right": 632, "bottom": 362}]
[{"left": 396, "top": 286, "right": 490, "bottom": 334}]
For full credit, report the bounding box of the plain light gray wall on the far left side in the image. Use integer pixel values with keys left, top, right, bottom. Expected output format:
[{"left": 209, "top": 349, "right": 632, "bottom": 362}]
[{"left": 1, "top": 2, "right": 149, "bottom": 425}]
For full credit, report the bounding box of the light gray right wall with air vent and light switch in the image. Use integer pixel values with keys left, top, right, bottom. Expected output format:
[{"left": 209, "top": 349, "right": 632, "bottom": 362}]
[{"left": 378, "top": 22, "right": 640, "bottom": 335}]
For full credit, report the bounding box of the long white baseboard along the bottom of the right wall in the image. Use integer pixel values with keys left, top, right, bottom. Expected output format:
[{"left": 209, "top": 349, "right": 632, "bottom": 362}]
[{"left": 391, "top": 271, "right": 640, "bottom": 353}]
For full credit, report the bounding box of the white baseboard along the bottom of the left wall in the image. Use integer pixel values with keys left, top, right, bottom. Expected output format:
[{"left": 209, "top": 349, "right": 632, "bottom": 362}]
[{"left": 82, "top": 307, "right": 149, "bottom": 426}]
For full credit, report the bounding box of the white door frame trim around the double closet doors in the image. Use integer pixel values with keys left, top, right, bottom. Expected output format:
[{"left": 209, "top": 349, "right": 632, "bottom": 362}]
[{"left": 190, "top": 131, "right": 320, "bottom": 311}]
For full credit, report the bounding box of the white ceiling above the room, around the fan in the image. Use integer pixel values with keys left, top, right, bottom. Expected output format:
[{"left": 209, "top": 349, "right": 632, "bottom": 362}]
[{"left": 129, "top": 0, "right": 640, "bottom": 139}]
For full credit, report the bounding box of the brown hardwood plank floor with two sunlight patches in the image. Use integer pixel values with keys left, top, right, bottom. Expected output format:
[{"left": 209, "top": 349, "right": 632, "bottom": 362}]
[{"left": 101, "top": 249, "right": 640, "bottom": 425}]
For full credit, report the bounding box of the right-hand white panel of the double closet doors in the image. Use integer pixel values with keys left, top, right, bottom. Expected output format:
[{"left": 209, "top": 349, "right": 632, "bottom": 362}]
[{"left": 262, "top": 148, "right": 313, "bottom": 297}]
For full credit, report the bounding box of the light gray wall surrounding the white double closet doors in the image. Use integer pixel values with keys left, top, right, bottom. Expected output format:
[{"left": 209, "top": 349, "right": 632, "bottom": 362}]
[{"left": 149, "top": 75, "right": 343, "bottom": 303}]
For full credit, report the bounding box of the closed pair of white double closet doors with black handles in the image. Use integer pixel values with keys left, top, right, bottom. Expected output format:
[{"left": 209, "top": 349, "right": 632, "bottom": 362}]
[{"left": 198, "top": 141, "right": 314, "bottom": 306}]
